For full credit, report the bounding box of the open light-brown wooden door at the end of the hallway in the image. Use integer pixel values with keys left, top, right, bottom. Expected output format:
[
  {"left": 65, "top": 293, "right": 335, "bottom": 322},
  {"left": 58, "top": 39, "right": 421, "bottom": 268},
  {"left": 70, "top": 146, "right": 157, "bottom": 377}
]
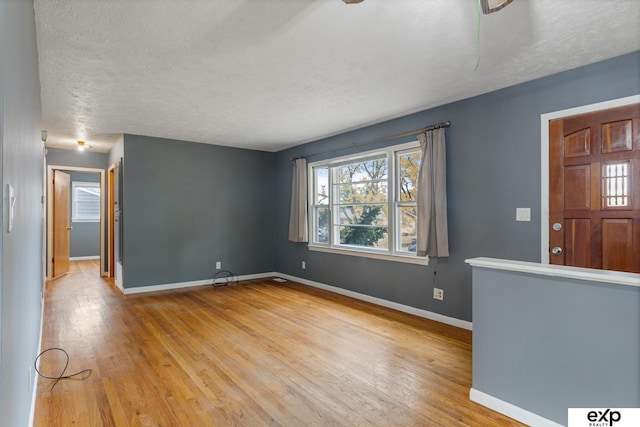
[{"left": 53, "top": 170, "right": 71, "bottom": 277}]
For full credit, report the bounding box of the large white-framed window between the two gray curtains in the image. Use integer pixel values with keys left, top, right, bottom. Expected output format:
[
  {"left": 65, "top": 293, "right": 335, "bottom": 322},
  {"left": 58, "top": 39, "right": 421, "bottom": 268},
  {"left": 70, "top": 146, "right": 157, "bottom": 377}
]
[{"left": 309, "top": 142, "right": 425, "bottom": 262}]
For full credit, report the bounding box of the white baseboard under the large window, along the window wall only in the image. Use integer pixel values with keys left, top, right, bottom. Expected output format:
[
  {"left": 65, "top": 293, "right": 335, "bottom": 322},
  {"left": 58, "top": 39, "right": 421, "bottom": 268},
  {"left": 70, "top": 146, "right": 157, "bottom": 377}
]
[{"left": 273, "top": 273, "right": 473, "bottom": 331}]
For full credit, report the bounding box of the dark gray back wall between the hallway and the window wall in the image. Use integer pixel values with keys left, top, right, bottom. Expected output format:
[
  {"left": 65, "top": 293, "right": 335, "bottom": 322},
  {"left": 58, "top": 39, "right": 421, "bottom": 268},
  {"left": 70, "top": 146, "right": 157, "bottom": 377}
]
[{"left": 122, "top": 135, "right": 278, "bottom": 288}]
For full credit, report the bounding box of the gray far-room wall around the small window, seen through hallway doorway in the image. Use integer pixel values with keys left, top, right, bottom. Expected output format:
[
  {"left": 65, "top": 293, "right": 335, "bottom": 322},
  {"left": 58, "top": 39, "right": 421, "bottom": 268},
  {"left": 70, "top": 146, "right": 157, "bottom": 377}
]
[{"left": 69, "top": 172, "right": 100, "bottom": 258}]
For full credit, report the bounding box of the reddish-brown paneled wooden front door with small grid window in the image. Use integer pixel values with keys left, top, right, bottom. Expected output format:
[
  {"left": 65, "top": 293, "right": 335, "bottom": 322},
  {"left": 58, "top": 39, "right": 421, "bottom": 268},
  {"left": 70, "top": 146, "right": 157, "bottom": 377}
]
[{"left": 549, "top": 104, "right": 640, "bottom": 273}]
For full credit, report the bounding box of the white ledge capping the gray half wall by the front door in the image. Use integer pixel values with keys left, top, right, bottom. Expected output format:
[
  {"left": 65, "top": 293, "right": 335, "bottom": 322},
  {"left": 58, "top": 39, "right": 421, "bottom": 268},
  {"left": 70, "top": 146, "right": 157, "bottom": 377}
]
[{"left": 465, "top": 258, "right": 640, "bottom": 287}]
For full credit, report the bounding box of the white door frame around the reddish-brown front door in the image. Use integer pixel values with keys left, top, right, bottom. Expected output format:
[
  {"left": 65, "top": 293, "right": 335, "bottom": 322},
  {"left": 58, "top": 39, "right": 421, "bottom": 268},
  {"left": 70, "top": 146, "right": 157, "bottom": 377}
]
[{"left": 540, "top": 94, "right": 640, "bottom": 264}]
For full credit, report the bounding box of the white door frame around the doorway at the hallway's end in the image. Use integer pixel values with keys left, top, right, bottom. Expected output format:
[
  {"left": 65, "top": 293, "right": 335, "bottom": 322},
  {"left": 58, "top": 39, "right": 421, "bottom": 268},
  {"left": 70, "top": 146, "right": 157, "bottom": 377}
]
[{"left": 46, "top": 165, "right": 107, "bottom": 279}]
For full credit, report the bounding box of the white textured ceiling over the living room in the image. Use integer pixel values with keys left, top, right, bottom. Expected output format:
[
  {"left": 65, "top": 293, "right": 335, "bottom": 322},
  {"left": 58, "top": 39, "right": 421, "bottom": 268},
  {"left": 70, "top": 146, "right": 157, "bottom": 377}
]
[{"left": 35, "top": 0, "right": 640, "bottom": 152}]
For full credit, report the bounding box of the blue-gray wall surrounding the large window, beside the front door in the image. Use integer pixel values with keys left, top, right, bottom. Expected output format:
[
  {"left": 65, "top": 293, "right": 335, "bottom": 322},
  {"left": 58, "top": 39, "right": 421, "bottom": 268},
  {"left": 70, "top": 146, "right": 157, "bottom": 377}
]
[{"left": 277, "top": 52, "right": 640, "bottom": 320}]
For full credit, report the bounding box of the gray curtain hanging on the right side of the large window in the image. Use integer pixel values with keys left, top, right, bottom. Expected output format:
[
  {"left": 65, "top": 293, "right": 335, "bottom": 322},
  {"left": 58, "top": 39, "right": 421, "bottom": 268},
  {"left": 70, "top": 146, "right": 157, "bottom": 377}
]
[{"left": 416, "top": 128, "right": 449, "bottom": 257}]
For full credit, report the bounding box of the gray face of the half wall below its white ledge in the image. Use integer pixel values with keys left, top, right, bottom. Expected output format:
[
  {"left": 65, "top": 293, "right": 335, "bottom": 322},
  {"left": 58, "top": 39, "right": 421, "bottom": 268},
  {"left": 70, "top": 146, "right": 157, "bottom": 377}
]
[{"left": 473, "top": 268, "right": 640, "bottom": 425}]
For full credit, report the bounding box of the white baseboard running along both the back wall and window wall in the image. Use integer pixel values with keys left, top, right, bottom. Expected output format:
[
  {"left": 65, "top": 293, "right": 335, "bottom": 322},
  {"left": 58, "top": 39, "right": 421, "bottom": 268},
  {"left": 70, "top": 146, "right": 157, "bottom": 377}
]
[{"left": 121, "top": 272, "right": 473, "bottom": 331}]
